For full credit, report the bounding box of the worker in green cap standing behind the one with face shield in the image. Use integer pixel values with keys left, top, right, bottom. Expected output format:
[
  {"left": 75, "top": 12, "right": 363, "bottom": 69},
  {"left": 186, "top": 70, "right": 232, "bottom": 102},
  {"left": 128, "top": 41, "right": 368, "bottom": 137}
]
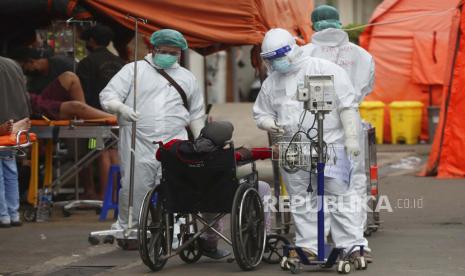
[{"left": 302, "top": 5, "right": 375, "bottom": 262}]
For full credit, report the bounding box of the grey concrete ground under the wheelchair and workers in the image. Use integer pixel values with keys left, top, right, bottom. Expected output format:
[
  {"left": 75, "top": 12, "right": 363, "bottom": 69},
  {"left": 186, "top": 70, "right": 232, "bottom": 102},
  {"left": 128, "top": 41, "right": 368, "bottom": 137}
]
[{"left": 0, "top": 145, "right": 465, "bottom": 276}]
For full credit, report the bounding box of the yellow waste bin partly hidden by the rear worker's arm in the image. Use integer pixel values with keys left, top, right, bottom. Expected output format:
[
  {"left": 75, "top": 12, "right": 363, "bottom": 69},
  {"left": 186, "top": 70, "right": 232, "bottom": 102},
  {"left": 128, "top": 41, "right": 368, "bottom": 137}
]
[{"left": 360, "top": 101, "right": 385, "bottom": 144}]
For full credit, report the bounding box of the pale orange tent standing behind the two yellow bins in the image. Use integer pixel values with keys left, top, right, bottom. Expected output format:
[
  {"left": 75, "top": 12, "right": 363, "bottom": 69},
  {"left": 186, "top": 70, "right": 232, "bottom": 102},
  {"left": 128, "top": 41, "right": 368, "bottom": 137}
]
[{"left": 360, "top": 0, "right": 460, "bottom": 141}]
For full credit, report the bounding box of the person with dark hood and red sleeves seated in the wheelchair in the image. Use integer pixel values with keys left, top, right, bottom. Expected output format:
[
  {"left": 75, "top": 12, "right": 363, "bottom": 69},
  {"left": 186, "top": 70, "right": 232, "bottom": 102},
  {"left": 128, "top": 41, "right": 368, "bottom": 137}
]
[{"left": 156, "top": 121, "right": 271, "bottom": 259}]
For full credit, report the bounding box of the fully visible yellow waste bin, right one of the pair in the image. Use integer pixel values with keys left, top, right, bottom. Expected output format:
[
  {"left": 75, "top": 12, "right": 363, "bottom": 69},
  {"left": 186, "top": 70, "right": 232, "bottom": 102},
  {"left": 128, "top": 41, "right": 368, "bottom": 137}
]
[{"left": 389, "top": 101, "right": 423, "bottom": 145}]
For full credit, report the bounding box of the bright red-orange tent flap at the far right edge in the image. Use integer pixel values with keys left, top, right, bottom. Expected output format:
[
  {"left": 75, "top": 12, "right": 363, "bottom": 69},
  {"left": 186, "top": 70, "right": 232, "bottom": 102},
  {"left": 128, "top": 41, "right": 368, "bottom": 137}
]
[{"left": 422, "top": 3, "right": 465, "bottom": 178}]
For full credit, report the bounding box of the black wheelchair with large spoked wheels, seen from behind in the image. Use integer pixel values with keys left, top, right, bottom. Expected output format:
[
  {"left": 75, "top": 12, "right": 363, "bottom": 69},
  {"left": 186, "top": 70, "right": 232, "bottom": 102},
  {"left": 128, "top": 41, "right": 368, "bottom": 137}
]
[{"left": 137, "top": 142, "right": 266, "bottom": 271}]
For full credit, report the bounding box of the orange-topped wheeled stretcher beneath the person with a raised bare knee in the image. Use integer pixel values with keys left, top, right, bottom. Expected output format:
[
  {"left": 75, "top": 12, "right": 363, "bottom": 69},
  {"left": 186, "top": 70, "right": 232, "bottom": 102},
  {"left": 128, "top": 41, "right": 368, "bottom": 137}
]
[{"left": 25, "top": 117, "right": 118, "bottom": 220}]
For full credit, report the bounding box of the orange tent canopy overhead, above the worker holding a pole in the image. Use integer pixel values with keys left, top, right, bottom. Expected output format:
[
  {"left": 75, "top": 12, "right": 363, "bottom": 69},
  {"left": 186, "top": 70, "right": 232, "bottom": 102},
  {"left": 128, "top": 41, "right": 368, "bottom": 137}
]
[{"left": 85, "top": 0, "right": 313, "bottom": 52}]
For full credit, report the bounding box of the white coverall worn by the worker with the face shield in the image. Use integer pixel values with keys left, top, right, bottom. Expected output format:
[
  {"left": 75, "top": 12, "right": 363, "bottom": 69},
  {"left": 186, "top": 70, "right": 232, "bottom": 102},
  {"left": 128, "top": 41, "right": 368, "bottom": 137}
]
[{"left": 253, "top": 56, "right": 366, "bottom": 253}]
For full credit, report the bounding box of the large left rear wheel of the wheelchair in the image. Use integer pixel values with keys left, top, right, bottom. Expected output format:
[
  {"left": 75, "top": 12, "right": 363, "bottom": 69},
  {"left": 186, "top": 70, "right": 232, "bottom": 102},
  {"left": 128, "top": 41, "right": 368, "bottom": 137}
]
[{"left": 137, "top": 189, "right": 173, "bottom": 271}]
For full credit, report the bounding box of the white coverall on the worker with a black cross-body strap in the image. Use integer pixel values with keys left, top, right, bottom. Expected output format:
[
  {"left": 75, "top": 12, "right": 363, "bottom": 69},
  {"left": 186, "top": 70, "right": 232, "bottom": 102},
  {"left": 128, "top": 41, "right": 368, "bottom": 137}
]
[{"left": 100, "top": 54, "right": 205, "bottom": 229}]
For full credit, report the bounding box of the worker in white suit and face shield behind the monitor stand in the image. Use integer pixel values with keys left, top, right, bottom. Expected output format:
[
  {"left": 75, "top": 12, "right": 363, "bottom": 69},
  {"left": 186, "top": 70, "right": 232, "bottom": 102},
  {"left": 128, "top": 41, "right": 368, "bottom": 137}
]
[{"left": 253, "top": 29, "right": 366, "bottom": 258}]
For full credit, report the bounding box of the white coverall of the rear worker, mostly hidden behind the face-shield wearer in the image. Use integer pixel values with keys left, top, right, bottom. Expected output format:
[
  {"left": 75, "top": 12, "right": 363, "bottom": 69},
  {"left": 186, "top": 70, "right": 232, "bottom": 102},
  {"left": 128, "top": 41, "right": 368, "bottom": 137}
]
[{"left": 302, "top": 28, "right": 375, "bottom": 244}]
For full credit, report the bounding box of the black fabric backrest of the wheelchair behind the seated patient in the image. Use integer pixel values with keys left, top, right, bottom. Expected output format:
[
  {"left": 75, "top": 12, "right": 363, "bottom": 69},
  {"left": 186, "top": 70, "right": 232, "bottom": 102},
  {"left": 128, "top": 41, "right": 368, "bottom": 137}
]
[{"left": 159, "top": 141, "right": 238, "bottom": 213}]
